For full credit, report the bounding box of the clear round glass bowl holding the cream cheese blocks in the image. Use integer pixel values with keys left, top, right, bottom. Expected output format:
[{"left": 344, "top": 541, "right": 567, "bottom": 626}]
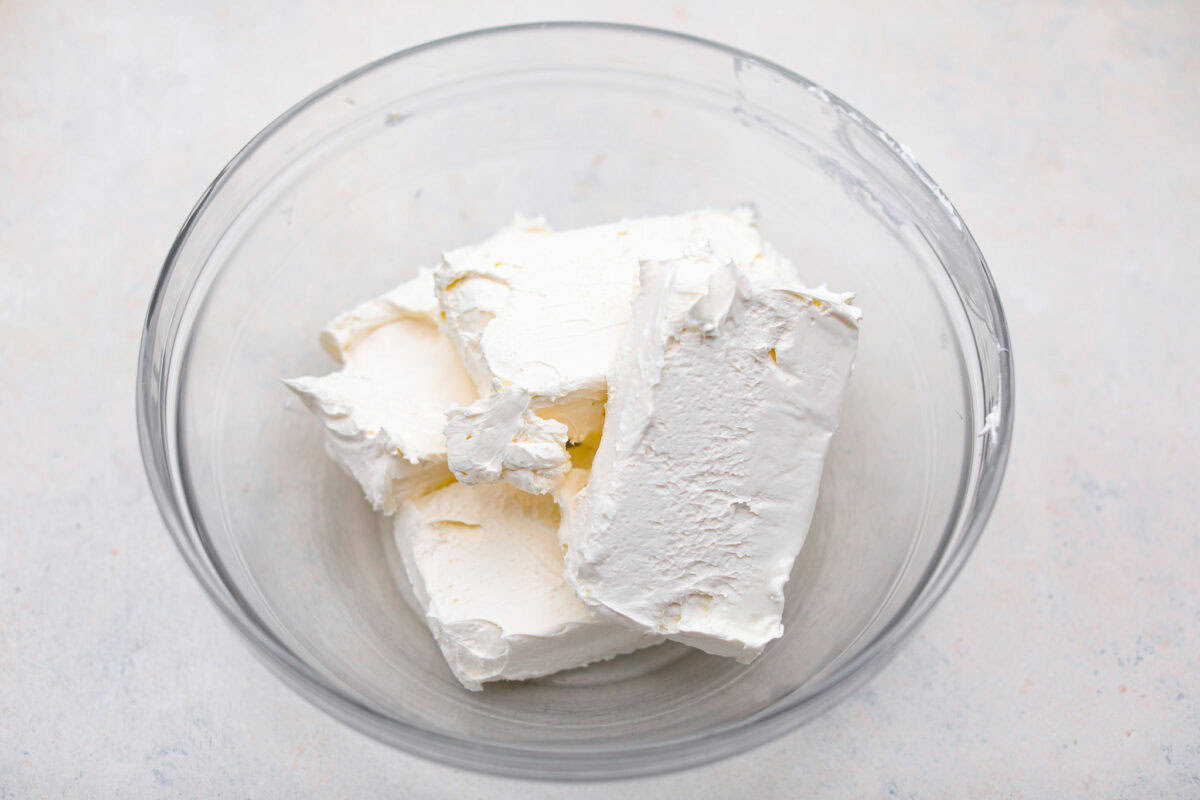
[{"left": 138, "top": 23, "right": 1013, "bottom": 780}]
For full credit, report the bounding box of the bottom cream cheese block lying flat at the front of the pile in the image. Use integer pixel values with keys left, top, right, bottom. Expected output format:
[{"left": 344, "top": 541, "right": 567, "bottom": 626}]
[{"left": 394, "top": 483, "right": 661, "bottom": 690}]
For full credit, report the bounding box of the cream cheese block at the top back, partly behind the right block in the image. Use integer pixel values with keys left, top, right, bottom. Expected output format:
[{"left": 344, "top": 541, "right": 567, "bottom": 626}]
[{"left": 434, "top": 209, "right": 793, "bottom": 441}]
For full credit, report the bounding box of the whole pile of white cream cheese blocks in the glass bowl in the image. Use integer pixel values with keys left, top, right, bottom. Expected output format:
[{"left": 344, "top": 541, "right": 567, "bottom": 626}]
[{"left": 284, "top": 209, "right": 860, "bottom": 690}]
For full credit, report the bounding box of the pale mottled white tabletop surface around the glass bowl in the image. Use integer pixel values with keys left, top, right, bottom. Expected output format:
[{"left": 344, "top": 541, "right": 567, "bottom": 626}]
[{"left": 0, "top": 0, "right": 1200, "bottom": 800}]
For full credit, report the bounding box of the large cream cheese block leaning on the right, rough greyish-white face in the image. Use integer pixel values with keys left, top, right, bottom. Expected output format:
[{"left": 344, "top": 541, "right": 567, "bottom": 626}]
[{"left": 560, "top": 251, "right": 860, "bottom": 662}]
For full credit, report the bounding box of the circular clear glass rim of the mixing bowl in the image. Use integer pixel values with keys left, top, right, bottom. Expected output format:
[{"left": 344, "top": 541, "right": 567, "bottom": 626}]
[{"left": 136, "top": 20, "right": 1015, "bottom": 781}]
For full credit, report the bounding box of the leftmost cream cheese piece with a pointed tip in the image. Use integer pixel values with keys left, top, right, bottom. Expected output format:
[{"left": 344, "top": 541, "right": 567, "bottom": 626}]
[{"left": 283, "top": 270, "right": 476, "bottom": 513}]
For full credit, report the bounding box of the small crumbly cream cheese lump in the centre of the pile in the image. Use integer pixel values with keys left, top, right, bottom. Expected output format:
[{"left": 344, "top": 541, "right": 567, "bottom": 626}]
[{"left": 445, "top": 384, "right": 571, "bottom": 494}]
